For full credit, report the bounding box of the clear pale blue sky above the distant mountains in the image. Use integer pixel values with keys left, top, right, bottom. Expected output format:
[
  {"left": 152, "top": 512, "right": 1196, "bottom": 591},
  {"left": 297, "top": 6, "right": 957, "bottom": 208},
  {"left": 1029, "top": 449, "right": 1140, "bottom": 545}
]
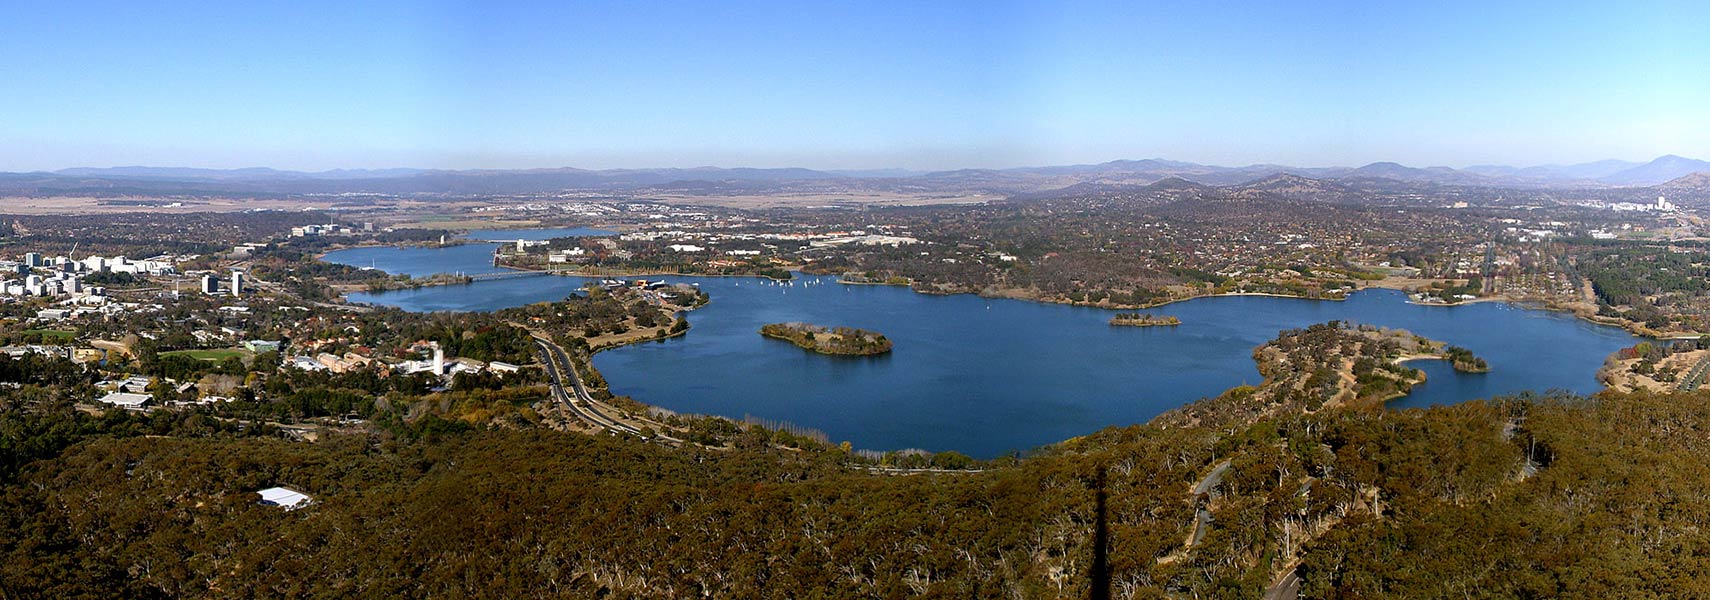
[{"left": 0, "top": 2, "right": 1710, "bottom": 171}]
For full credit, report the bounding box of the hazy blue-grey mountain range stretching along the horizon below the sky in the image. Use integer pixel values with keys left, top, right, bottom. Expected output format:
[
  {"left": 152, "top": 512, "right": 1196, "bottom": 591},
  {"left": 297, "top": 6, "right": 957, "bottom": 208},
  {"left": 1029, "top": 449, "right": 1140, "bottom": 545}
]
[{"left": 0, "top": 154, "right": 1710, "bottom": 195}]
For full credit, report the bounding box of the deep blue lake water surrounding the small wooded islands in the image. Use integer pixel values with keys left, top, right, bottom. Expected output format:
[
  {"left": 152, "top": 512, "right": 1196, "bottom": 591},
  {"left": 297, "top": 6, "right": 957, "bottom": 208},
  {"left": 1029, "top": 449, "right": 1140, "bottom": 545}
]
[{"left": 327, "top": 232, "right": 1636, "bottom": 458}]
